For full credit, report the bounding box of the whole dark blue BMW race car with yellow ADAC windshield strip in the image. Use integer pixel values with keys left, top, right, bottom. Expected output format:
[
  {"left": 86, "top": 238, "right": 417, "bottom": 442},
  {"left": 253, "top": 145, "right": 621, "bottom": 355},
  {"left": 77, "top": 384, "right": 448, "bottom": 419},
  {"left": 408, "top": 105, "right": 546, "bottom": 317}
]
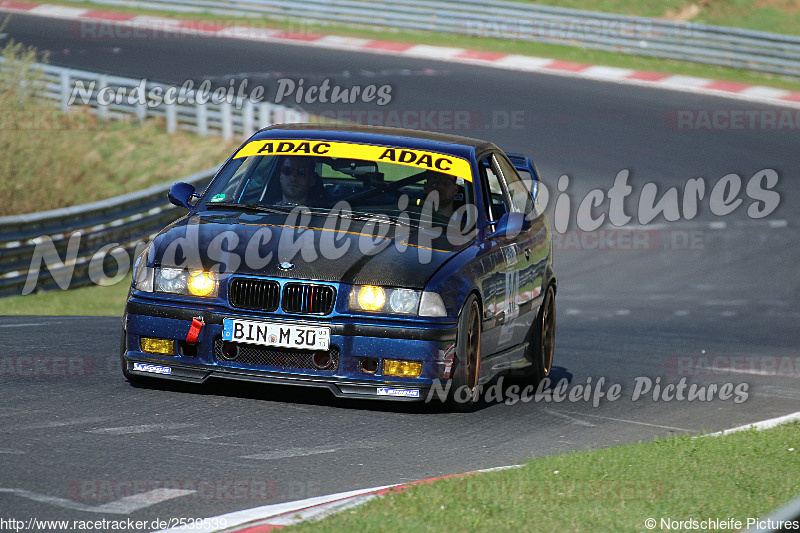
[{"left": 121, "top": 124, "right": 556, "bottom": 410}]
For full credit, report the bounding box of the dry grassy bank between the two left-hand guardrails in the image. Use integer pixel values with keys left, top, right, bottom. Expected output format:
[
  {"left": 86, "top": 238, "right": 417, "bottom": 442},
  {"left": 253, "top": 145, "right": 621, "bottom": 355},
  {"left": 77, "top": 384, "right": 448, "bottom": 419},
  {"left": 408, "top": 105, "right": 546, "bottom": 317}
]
[{"left": 0, "top": 37, "right": 240, "bottom": 216}]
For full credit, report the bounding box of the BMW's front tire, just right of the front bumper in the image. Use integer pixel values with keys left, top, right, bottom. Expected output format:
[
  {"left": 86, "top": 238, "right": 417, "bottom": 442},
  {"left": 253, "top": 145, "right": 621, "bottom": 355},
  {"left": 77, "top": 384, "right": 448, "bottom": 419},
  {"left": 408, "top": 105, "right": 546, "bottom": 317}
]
[{"left": 447, "top": 294, "right": 481, "bottom": 412}]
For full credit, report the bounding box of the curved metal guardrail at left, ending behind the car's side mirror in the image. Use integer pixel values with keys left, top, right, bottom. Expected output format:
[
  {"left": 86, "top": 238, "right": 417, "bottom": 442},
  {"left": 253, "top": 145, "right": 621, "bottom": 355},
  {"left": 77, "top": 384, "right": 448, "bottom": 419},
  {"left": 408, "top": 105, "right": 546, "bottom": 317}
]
[{"left": 0, "top": 169, "right": 215, "bottom": 297}]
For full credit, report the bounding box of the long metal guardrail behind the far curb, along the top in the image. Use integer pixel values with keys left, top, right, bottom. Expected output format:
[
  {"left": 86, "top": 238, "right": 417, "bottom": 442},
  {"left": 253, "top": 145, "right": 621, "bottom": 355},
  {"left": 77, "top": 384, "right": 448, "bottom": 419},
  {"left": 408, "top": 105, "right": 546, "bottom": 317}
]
[{"left": 62, "top": 0, "right": 800, "bottom": 77}]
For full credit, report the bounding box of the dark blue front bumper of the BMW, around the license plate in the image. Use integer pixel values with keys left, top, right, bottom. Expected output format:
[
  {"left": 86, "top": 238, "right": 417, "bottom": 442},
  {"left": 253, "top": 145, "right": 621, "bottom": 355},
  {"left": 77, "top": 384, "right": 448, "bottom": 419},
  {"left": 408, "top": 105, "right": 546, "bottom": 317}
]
[{"left": 121, "top": 296, "right": 457, "bottom": 401}]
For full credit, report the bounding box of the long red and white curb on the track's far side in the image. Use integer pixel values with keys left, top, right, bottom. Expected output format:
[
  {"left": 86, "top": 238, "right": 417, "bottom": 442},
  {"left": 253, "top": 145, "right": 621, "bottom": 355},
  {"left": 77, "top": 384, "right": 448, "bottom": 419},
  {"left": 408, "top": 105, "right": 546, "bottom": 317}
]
[{"left": 0, "top": 0, "right": 800, "bottom": 108}]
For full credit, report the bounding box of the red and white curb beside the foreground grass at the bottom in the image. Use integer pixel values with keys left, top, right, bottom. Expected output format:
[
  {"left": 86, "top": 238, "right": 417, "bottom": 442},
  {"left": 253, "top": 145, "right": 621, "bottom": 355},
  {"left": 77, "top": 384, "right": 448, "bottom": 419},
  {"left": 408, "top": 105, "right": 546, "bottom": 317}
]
[{"left": 156, "top": 465, "right": 522, "bottom": 533}]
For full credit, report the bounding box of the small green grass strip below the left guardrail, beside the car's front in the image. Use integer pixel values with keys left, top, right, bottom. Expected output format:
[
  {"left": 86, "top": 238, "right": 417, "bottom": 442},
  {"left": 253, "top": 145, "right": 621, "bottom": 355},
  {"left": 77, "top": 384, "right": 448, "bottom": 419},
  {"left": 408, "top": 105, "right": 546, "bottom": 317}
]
[{"left": 0, "top": 274, "right": 131, "bottom": 317}]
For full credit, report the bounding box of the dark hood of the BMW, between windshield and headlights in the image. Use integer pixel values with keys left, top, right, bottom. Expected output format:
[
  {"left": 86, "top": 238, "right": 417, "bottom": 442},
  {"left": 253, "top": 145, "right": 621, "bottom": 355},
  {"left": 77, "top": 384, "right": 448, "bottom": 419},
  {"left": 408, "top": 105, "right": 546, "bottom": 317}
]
[{"left": 148, "top": 211, "right": 472, "bottom": 289}]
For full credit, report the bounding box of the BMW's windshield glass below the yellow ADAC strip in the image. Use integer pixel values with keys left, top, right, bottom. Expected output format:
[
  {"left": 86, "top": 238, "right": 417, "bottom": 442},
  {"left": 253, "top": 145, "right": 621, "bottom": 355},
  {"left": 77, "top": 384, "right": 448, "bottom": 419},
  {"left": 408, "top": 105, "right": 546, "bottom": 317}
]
[{"left": 200, "top": 147, "right": 477, "bottom": 227}]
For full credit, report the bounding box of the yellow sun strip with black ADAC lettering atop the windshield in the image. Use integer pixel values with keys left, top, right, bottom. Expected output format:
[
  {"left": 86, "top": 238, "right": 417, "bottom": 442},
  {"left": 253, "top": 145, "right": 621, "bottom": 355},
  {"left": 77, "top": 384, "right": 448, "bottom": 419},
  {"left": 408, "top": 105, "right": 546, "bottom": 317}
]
[{"left": 233, "top": 139, "right": 472, "bottom": 181}]
